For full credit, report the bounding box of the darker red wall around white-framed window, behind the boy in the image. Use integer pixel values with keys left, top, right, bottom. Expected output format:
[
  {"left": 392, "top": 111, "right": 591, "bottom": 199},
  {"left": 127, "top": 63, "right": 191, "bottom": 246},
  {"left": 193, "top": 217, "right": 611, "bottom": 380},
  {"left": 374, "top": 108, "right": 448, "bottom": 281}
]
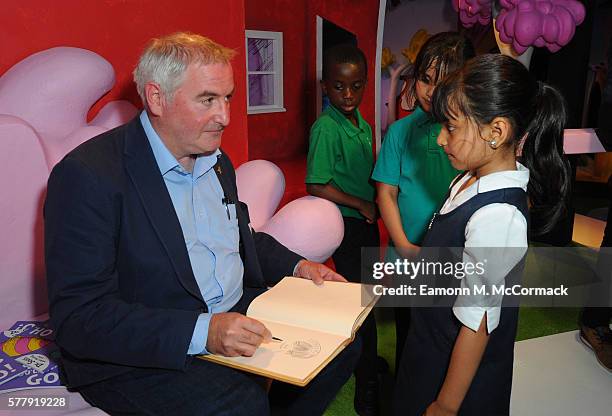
[{"left": 245, "top": 0, "right": 379, "bottom": 161}]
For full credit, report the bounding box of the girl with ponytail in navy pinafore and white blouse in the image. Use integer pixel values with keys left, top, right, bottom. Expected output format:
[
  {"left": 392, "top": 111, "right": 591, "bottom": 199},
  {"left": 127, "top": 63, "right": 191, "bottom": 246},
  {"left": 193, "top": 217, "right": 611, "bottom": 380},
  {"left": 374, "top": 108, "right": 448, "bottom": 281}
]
[{"left": 394, "top": 54, "right": 570, "bottom": 416}]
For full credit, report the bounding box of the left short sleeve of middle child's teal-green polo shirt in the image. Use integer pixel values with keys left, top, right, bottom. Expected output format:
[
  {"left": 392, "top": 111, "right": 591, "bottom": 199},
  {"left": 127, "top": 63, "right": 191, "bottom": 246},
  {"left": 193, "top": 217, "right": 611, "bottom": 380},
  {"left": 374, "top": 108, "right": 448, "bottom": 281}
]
[{"left": 372, "top": 120, "right": 405, "bottom": 186}]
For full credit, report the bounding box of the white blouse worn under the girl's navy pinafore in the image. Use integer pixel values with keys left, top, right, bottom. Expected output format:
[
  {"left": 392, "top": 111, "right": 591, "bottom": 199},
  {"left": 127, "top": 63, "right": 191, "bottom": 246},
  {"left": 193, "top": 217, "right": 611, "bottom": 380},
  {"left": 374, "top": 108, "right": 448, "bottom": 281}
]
[{"left": 440, "top": 162, "right": 529, "bottom": 333}]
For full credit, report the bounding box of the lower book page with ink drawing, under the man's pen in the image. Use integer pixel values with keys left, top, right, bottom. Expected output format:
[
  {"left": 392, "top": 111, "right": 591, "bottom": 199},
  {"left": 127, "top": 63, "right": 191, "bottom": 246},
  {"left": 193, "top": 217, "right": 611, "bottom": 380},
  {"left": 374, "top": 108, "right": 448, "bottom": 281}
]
[{"left": 202, "top": 320, "right": 347, "bottom": 385}]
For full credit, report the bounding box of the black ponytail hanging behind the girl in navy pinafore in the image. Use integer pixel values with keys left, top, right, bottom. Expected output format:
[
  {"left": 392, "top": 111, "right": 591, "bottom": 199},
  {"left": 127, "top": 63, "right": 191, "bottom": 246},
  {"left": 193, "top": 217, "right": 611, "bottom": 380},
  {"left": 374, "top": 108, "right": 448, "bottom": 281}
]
[{"left": 520, "top": 81, "right": 571, "bottom": 235}]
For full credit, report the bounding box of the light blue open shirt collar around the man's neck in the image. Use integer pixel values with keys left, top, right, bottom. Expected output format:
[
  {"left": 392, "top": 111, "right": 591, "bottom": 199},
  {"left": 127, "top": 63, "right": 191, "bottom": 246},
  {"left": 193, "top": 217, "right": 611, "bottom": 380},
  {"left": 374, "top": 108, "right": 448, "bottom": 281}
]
[{"left": 140, "top": 110, "right": 221, "bottom": 178}]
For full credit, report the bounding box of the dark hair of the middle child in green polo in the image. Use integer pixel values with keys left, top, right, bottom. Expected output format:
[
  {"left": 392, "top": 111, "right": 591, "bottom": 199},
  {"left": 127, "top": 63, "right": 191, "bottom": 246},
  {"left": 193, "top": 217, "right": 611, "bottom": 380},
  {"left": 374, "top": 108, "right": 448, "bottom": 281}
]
[{"left": 406, "top": 32, "right": 474, "bottom": 111}]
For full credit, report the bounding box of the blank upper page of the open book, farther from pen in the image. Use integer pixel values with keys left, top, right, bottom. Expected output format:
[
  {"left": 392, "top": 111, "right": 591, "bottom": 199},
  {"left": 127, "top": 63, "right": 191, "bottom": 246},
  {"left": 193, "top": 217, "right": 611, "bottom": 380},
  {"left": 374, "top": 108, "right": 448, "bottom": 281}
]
[{"left": 247, "top": 277, "right": 374, "bottom": 338}]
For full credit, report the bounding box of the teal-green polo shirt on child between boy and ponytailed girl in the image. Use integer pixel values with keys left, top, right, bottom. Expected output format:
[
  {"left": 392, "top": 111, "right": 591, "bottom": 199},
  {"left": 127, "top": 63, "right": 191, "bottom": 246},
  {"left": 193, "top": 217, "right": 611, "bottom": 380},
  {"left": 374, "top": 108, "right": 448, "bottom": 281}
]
[{"left": 372, "top": 107, "right": 459, "bottom": 244}]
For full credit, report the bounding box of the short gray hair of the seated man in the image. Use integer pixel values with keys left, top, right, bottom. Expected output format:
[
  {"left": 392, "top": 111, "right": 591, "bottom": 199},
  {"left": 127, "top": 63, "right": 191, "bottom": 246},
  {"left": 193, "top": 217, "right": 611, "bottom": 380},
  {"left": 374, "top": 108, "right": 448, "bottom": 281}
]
[{"left": 134, "top": 32, "right": 236, "bottom": 108}]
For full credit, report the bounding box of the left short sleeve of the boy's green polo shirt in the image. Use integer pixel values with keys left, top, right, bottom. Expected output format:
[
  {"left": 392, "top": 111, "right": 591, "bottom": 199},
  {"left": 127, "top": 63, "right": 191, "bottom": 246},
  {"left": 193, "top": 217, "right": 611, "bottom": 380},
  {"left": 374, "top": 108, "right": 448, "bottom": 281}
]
[{"left": 305, "top": 120, "right": 340, "bottom": 184}]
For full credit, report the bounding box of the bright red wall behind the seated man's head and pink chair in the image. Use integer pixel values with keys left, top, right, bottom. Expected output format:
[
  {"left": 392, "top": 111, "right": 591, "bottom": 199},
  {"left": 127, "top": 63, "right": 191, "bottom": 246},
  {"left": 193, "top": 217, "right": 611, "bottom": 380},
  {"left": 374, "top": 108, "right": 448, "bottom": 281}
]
[{"left": 0, "top": 0, "right": 248, "bottom": 165}]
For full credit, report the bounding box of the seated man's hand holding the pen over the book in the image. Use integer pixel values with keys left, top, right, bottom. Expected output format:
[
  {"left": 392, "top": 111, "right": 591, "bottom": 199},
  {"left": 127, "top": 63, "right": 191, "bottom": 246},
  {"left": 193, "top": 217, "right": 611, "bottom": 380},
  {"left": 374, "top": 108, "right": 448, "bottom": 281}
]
[{"left": 206, "top": 312, "right": 272, "bottom": 357}]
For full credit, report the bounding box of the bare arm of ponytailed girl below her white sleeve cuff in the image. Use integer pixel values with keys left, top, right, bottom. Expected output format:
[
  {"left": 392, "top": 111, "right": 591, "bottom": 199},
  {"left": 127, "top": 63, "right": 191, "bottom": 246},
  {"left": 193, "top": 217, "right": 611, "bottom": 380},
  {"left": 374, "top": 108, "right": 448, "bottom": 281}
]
[{"left": 425, "top": 314, "right": 489, "bottom": 416}]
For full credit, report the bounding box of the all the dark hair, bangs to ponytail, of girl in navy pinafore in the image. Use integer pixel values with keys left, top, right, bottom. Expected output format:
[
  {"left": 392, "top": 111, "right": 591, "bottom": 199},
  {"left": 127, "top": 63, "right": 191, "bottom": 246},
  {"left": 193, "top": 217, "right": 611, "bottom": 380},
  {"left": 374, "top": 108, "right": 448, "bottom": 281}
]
[{"left": 432, "top": 54, "right": 570, "bottom": 235}]
